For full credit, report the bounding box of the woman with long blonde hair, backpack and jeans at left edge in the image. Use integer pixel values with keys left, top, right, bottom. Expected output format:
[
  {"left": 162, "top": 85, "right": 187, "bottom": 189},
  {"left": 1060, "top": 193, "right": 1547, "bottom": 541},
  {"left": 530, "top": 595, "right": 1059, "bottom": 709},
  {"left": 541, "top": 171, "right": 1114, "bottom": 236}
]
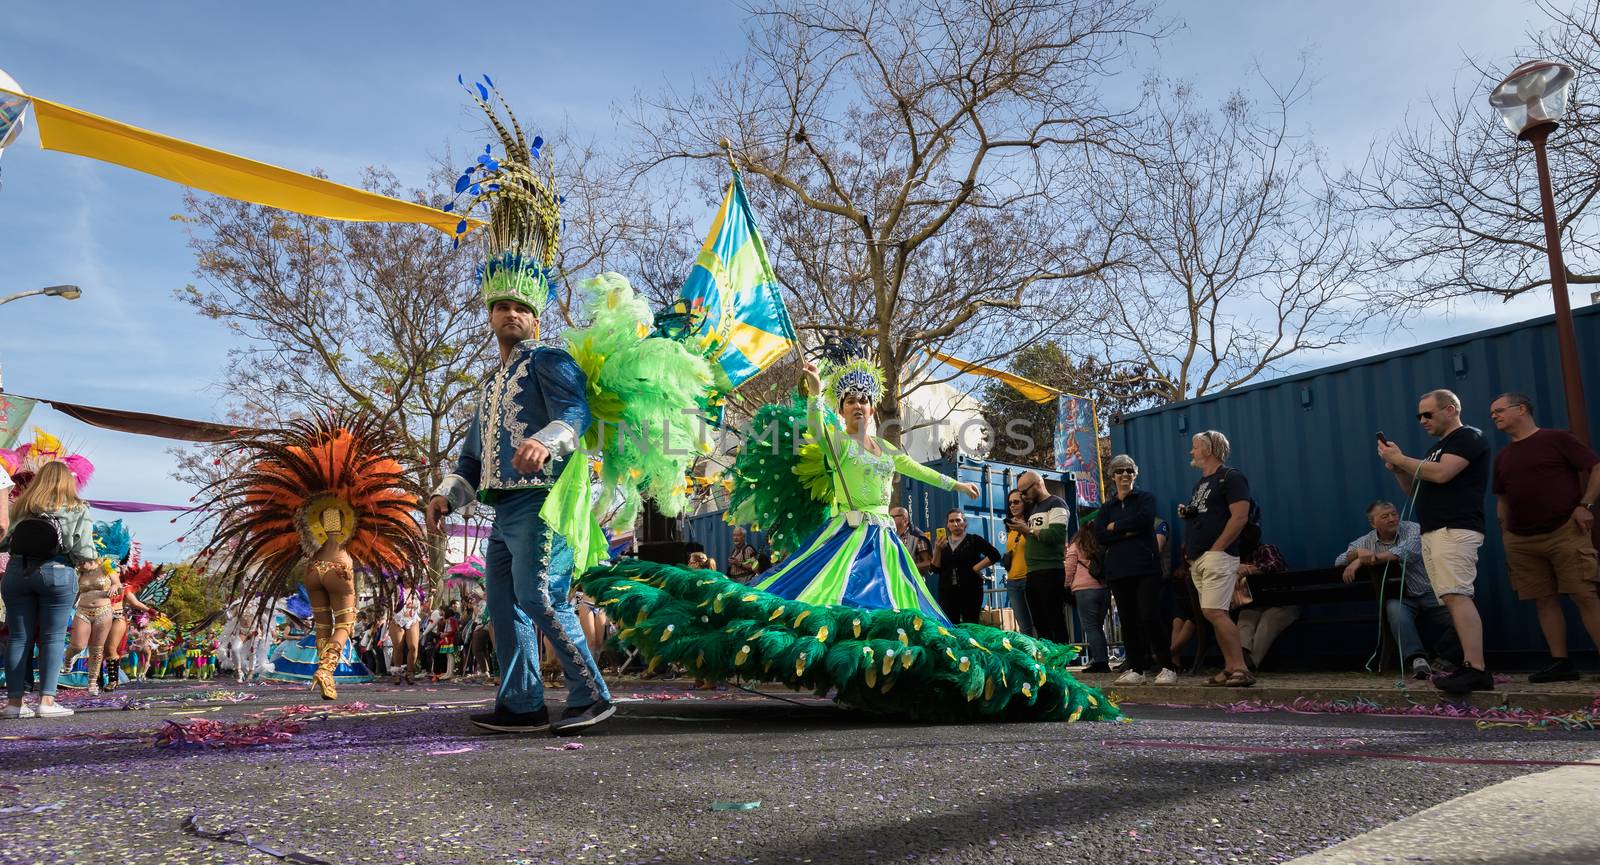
[{"left": 0, "top": 462, "right": 96, "bottom": 718}]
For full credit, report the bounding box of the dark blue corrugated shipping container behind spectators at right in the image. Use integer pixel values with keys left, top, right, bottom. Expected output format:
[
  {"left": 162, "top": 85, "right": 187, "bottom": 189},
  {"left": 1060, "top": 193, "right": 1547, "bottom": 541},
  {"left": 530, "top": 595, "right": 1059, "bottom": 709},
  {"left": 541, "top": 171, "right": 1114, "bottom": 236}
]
[{"left": 1112, "top": 307, "right": 1600, "bottom": 654}]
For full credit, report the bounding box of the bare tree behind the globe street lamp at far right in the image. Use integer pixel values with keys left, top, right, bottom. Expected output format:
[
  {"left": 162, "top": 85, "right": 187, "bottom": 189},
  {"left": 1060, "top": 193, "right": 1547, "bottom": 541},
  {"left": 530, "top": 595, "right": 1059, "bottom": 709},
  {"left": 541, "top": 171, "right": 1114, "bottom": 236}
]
[{"left": 1344, "top": 0, "right": 1600, "bottom": 307}]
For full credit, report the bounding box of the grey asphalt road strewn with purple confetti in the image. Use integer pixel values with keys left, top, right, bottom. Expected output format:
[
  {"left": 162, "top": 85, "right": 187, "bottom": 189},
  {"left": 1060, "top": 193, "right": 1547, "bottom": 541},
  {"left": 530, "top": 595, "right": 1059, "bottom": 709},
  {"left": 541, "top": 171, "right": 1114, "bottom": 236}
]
[{"left": 0, "top": 681, "right": 1600, "bottom": 865}]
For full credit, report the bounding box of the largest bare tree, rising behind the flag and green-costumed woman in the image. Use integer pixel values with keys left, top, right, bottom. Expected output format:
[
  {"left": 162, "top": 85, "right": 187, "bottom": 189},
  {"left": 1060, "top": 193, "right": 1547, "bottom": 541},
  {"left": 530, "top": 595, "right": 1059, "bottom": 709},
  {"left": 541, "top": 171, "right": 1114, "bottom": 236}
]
[{"left": 630, "top": 0, "right": 1163, "bottom": 441}]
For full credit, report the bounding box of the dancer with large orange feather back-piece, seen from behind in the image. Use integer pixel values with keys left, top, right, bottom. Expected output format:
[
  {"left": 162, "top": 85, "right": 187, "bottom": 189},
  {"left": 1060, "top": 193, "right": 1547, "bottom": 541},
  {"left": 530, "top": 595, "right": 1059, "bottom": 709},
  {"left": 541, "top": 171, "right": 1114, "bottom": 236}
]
[{"left": 202, "top": 413, "right": 427, "bottom": 700}]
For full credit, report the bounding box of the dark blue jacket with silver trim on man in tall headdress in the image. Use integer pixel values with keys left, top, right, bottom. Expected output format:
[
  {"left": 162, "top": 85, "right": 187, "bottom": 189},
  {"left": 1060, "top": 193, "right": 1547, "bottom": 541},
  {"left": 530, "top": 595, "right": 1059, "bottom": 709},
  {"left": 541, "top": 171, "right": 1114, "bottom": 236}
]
[{"left": 434, "top": 339, "right": 590, "bottom": 508}]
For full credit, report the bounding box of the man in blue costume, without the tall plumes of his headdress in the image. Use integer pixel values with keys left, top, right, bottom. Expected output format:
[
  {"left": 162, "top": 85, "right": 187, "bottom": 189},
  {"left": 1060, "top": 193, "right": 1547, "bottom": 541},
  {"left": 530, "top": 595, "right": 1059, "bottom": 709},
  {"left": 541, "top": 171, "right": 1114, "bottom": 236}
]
[{"left": 427, "top": 294, "right": 616, "bottom": 732}]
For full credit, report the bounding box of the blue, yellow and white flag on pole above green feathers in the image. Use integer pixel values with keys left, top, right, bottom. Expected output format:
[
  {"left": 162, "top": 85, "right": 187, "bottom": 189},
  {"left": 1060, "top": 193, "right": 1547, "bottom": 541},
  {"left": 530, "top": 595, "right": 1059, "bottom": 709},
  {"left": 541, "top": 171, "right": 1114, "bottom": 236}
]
[{"left": 675, "top": 171, "right": 798, "bottom": 393}]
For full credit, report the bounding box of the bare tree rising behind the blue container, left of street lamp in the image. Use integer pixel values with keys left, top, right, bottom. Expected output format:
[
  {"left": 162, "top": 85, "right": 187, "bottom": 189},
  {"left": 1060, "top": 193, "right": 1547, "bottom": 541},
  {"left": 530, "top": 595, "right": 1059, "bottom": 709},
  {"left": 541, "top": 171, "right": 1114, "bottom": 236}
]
[{"left": 1098, "top": 70, "right": 1374, "bottom": 401}]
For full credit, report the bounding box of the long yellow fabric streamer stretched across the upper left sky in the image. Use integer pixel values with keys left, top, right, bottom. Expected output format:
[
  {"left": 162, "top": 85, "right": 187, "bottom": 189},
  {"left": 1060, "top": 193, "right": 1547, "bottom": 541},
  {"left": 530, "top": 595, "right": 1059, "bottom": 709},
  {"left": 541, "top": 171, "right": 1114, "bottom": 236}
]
[{"left": 5, "top": 90, "right": 483, "bottom": 235}]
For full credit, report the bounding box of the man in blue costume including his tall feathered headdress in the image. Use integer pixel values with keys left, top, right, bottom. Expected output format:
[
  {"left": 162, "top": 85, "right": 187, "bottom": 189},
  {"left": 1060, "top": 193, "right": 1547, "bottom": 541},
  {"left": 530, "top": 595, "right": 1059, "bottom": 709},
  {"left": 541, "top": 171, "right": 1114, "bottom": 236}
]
[{"left": 427, "top": 80, "right": 616, "bottom": 732}]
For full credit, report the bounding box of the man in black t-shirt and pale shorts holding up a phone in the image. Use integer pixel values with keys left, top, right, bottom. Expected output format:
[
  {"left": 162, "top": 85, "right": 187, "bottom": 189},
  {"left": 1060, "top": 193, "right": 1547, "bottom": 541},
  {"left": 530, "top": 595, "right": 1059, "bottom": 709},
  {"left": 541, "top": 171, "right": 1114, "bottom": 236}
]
[{"left": 1378, "top": 390, "right": 1494, "bottom": 694}]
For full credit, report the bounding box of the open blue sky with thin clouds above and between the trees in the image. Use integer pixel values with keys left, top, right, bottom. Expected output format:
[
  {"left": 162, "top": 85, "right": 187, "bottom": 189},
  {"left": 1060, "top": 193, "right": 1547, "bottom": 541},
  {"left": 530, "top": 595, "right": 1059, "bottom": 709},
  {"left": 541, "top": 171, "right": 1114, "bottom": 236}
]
[{"left": 0, "top": 0, "right": 1555, "bottom": 558}]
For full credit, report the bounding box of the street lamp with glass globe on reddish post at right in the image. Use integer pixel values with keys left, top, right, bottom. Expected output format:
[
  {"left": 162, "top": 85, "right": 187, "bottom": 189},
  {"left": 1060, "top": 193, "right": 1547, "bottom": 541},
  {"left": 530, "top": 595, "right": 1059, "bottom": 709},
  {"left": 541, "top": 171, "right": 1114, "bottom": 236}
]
[{"left": 1490, "top": 61, "right": 1589, "bottom": 444}]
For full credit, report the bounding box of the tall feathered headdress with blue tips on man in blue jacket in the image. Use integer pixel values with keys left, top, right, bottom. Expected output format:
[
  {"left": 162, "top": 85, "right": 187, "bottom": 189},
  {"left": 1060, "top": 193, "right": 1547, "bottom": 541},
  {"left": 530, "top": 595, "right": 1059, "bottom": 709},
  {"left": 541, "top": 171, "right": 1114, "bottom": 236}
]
[{"left": 445, "top": 75, "right": 562, "bottom": 313}]
